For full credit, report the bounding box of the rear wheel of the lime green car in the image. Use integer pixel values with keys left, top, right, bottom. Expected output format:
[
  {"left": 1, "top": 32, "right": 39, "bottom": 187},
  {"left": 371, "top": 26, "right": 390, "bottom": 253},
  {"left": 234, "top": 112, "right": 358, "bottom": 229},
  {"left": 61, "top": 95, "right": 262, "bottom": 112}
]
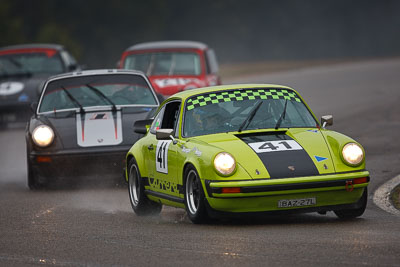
[{"left": 128, "top": 159, "right": 162, "bottom": 216}]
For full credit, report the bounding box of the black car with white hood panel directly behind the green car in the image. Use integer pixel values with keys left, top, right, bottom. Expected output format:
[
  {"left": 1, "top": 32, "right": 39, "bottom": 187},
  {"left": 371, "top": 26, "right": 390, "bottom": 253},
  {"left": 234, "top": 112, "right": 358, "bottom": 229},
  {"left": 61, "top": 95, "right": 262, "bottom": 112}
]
[{"left": 26, "top": 70, "right": 160, "bottom": 189}]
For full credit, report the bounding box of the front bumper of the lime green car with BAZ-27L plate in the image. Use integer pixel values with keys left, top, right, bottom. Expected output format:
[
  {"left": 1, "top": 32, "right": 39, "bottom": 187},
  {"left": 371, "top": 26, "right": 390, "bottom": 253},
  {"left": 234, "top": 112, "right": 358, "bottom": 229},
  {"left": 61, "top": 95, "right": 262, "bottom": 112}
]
[{"left": 204, "top": 170, "right": 370, "bottom": 213}]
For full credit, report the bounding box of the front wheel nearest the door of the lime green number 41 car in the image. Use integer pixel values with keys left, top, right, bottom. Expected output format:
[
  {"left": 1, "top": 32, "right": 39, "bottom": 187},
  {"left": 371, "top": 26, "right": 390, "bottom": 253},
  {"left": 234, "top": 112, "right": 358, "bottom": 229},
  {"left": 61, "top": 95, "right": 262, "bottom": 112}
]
[{"left": 184, "top": 166, "right": 209, "bottom": 223}]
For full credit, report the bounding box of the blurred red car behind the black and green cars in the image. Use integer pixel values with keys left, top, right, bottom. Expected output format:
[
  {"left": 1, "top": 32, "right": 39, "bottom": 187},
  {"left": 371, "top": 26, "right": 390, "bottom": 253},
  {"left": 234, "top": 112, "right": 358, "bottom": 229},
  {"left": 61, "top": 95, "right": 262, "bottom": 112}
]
[{"left": 119, "top": 41, "right": 221, "bottom": 96}]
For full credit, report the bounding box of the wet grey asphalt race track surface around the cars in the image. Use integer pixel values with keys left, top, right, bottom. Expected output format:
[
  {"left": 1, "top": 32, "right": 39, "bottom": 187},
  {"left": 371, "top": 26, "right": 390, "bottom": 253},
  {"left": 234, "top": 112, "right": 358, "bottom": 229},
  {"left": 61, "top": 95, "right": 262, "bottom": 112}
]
[{"left": 0, "top": 59, "right": 400, "bottom": 266}]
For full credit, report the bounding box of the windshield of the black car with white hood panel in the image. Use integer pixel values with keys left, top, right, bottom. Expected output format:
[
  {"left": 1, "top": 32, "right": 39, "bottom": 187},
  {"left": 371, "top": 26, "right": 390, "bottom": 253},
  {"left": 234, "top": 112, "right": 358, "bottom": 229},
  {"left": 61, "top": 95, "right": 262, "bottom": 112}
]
[{"left": 39, "top": 74, "right": 157, "bottom": 112}]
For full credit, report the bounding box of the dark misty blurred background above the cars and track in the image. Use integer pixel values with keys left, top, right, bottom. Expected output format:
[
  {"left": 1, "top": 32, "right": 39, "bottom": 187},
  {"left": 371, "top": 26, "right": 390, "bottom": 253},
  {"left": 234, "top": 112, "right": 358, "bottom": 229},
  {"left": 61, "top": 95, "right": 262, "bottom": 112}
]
[{"left": 0, "top": 0, "right": 400, "bottom": 68}]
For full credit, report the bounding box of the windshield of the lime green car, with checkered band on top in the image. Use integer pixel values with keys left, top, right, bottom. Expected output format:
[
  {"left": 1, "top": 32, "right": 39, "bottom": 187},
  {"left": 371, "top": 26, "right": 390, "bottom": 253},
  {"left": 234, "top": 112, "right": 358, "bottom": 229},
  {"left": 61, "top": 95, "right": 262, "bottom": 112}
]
[{"left": 183, "top": 88, "right": 317, "bottom": 137}]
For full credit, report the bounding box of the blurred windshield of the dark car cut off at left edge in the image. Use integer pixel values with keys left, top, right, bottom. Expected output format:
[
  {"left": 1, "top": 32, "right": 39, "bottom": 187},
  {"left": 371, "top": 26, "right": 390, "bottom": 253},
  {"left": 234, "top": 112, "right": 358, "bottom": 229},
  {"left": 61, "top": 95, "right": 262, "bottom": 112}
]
[{"left": 0, "top": 50, "right": 65, "bottom": 76}]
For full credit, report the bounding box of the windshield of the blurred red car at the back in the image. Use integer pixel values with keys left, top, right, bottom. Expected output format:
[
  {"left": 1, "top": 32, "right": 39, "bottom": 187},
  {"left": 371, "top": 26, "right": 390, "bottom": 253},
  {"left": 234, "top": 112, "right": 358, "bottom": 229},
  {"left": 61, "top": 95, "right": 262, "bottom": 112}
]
[{"left": 124, "top": 52, "right": 201, "bottom": 76}]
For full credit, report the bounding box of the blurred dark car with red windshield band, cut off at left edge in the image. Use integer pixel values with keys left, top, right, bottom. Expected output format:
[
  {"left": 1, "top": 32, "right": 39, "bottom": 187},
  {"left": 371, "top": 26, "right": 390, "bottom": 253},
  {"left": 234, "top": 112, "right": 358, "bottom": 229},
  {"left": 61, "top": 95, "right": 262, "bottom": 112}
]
[{"left": 0, "top": 44, "right": 80, "bottom": 124}]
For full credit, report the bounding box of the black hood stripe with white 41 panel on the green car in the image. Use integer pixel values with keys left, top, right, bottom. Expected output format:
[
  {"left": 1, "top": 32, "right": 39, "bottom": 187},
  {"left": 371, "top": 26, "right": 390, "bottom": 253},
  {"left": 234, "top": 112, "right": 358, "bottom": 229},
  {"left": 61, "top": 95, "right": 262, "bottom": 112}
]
[{"left": 238, "top": 132, "right": 319, "bottom": 178}]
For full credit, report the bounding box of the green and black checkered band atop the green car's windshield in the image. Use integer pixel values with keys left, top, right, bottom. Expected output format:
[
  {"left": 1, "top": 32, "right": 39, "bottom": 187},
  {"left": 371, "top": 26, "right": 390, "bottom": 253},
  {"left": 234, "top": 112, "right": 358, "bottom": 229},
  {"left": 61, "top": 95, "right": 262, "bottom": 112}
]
[{"left": 186, "top": 89, "right": 301, "bottom": 110}]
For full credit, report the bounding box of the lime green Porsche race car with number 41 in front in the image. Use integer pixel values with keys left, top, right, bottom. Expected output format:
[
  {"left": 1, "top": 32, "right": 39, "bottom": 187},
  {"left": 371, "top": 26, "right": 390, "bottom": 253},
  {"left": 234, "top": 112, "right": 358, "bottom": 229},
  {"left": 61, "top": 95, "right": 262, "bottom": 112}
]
[{"left": 126, "top": 84, "right": 370, "bottom": 223}]
